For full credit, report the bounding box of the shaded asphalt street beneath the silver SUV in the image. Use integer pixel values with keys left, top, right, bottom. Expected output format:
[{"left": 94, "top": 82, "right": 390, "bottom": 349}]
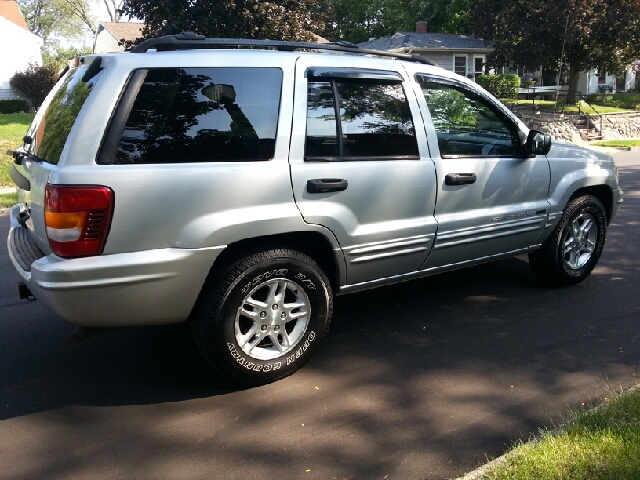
[{"left": 0, "top": 152, "right": 640, "bottom": 480}]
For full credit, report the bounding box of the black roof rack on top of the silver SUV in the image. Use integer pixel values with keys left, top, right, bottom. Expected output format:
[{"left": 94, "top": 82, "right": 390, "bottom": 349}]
[{"left": 131, "top": 32, "right": 438, "bottom": 66}]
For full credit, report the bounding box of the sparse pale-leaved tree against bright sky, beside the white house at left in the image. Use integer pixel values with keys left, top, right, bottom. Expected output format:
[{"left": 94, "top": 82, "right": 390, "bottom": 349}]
[{"left": 18, "top": 0, "right": 96, "bottom": 47}]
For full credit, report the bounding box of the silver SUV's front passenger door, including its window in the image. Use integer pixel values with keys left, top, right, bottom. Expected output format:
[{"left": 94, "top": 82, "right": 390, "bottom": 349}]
[{"left": 416, "top": 74, "right": 550, "bottom": 269}]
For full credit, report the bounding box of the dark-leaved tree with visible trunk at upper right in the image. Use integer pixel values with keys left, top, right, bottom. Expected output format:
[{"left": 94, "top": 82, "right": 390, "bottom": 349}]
[{"left": 473, "top": 0, "right": 640, "bottom": 102}]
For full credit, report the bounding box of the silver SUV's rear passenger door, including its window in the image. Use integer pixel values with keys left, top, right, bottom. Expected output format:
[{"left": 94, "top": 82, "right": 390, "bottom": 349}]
[{"left": 290, "top": 55, "right": 436, "bottom": 285}]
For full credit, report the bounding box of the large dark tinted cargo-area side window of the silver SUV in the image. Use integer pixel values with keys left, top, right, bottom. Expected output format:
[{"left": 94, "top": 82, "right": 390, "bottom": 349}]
[{"left": 115, "top": 68, "right": 282, "bottom": 163}]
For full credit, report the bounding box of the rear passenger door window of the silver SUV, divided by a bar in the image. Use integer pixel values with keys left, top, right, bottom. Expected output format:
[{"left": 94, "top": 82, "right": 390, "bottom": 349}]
[{"left": 305, "top": 80, "right": 418, "bottom": 159}]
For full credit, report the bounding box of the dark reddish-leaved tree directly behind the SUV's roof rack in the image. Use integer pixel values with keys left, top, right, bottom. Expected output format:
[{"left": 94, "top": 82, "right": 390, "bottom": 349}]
[{"left": 122, "top": 0, "right": 324, "bottom": 40}]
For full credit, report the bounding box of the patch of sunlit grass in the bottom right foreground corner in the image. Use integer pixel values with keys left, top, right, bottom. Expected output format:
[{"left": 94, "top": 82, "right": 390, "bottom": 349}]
[{"left": 482, "top": 388, "right": 640, "bottom": 480}]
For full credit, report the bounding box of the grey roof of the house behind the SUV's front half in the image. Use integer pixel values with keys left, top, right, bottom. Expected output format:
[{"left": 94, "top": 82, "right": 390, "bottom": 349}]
[{"left": 358, "top": 32, "right": 493, "bottom": 52}]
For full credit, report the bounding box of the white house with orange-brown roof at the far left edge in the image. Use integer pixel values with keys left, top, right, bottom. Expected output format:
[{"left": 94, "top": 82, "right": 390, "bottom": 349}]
[{"left": 0, "top": 0, "right": 42, "bottom": 100}]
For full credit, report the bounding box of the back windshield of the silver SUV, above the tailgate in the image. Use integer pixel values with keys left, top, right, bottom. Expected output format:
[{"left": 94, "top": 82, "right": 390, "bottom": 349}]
[{"left": 29, "top": 57, "right": 102, "bottom": 164}]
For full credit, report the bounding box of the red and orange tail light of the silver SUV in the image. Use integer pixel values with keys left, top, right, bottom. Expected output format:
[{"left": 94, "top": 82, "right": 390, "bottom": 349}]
[{"left": 44, "top": 185, "right": 113, "bottom": 257}]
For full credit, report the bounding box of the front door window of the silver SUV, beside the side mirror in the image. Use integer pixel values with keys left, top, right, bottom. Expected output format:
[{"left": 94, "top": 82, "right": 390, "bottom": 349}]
[{"left": 418, "top": 79, "right": 521, "bottom": 157}]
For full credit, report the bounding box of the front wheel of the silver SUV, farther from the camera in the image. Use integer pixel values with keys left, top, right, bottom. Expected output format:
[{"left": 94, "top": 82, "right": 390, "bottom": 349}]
[{"left": 529, "top": 195, "right": 607, "bottom": 286}]
